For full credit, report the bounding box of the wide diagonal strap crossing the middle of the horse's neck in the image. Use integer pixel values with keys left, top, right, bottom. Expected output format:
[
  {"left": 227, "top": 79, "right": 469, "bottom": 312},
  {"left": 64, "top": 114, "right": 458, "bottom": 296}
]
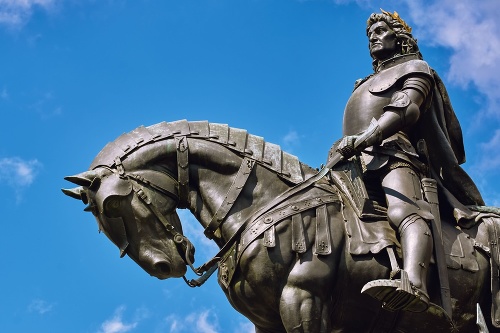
[{"left": 205, "top": 157, "right": 255, "bottom": 239}]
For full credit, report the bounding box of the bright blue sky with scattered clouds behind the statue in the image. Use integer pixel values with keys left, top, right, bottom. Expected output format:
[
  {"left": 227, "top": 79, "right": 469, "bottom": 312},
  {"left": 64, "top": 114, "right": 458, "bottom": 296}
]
[{"left": 0, "top": 0, "right": 500, "bottom": 333}]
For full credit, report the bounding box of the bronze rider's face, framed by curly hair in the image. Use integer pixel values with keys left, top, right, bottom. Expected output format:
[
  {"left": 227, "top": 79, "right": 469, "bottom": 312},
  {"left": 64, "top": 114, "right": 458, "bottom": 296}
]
[{"left": 368, "top": 21, "right": 397, "bottom": 60}]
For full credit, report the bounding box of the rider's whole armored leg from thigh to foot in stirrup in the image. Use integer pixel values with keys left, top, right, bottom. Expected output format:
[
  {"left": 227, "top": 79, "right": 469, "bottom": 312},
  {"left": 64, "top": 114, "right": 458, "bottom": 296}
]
[{"left": 362, "top": 167, "right": 433, "bottom": 312}]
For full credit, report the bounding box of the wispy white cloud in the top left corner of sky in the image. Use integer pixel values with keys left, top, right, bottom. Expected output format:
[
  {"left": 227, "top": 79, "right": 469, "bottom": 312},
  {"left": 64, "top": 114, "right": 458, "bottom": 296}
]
[{"left": 0, "top": 0, "right": 60, "bottom": 29}]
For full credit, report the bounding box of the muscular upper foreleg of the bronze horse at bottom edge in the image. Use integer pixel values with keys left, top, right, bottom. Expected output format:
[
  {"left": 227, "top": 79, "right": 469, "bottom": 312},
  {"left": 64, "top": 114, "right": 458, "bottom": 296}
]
[{"left": 280, "top": 256, "right": 333, "bottom": 333}]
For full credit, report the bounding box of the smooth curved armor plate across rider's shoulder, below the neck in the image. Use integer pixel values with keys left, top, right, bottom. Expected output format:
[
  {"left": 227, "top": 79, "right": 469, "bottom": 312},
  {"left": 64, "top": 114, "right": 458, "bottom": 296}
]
[{"left": 368, "top": 60, "right": 432, "bottom": 94}]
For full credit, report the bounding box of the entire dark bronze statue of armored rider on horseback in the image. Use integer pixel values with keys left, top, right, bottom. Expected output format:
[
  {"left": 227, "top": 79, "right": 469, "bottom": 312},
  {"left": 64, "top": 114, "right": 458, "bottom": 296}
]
[{"left": 63, "top": 12, "right": 500, "bottom": 333}]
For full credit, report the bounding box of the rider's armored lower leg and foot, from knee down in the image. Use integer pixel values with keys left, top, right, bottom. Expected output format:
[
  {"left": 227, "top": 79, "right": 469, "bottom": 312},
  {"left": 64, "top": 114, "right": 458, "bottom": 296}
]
[{"left": 361, "top": 215, "right": 432, "bottom": 312}]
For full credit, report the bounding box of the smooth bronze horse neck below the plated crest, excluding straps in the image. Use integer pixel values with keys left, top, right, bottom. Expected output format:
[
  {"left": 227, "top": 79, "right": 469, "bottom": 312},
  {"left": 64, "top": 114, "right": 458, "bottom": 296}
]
[{"left": 123, "top": 138, "right": 298, "bottom": 243}]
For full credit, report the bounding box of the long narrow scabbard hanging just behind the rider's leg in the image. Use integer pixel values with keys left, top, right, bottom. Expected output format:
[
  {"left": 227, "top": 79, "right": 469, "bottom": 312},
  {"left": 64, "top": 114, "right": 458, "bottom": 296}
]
[{"left": 422, "top": 178, "right": 452, "bottom": 319}]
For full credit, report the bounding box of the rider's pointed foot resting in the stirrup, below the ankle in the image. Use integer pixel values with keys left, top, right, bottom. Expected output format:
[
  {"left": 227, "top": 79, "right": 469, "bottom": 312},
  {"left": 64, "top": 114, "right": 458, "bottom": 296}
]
[{"left": 361, "top": 270, "right": 429, "bottom": 312}]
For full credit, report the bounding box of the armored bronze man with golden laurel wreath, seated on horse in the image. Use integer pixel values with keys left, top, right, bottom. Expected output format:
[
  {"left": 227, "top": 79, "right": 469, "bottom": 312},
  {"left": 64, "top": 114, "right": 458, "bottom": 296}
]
[{"left": 337, "top": 11, "right": 482, "bottom": 311}]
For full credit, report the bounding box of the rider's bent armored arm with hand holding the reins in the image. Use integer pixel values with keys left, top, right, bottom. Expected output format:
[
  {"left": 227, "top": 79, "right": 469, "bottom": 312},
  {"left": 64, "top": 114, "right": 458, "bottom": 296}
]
[{"left": 337, "top": 76, "right": 432, "bottom": 158}]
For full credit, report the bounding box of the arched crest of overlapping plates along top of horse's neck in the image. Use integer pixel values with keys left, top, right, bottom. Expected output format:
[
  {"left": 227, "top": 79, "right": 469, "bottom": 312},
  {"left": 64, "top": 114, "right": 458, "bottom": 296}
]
[{"left": 90, "top": 120, "right": 313, "bottom": 184}]
